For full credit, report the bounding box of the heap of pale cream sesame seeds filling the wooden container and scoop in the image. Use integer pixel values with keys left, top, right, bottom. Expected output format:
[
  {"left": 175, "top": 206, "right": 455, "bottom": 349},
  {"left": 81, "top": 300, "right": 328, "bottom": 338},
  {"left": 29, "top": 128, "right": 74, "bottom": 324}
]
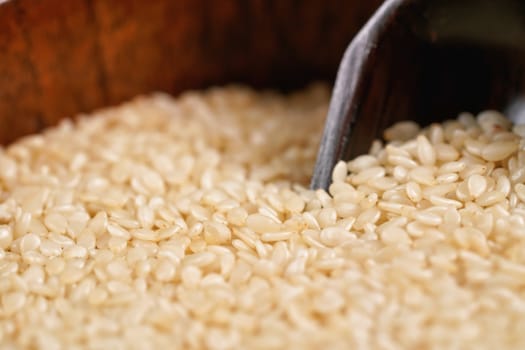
[{"left": 0, "top": 86, "right": 525, "bottom": 349}]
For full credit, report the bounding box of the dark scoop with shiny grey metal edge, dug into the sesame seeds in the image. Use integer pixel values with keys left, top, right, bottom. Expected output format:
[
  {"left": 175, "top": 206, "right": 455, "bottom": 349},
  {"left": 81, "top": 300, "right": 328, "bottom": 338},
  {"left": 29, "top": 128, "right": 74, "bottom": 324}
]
[{"left": 311, "top": 0, "right": 525, "bottom": 189}]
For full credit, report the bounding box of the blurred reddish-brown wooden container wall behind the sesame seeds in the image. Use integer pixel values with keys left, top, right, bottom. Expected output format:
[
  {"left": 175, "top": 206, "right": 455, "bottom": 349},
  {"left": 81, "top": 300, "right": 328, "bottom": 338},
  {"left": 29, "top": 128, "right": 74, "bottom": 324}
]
[{"left": 0, "top": 0, "right": 381, "bottom": 143}]
